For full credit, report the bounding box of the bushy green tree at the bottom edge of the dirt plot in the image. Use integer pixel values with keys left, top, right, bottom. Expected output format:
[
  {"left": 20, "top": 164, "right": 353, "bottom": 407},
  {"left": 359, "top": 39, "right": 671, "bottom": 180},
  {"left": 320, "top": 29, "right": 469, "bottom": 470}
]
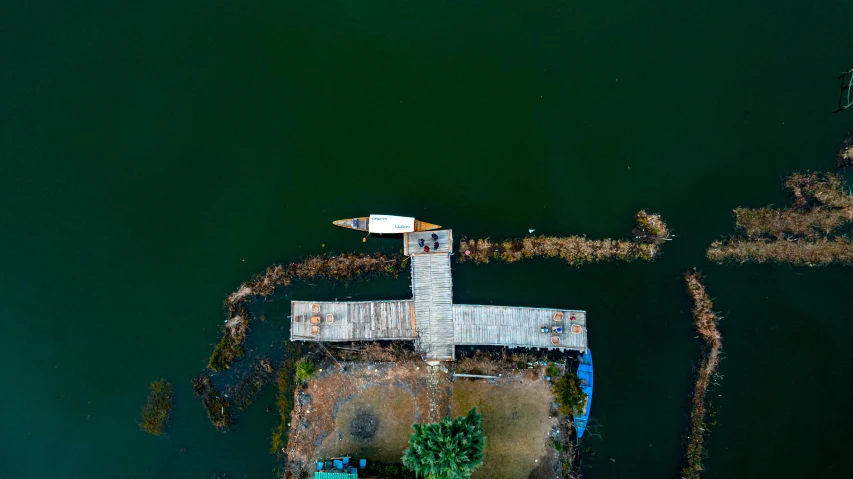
[{"left": 403, "top": 408, "right": 486, "bottom": 479}]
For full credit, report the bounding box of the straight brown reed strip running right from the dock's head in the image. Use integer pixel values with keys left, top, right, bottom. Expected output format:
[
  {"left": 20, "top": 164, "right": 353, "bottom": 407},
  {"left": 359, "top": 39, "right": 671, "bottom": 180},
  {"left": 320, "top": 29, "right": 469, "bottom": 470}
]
[{"left": 458, "top": 211, "right": 669, "bottom": 266}]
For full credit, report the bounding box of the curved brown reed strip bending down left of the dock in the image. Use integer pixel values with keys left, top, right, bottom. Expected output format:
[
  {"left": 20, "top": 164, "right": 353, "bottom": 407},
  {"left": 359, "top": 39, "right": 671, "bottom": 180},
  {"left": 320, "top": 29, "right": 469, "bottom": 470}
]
[{"left": 208, "top": 253, "right": 406, "bottom": 371}]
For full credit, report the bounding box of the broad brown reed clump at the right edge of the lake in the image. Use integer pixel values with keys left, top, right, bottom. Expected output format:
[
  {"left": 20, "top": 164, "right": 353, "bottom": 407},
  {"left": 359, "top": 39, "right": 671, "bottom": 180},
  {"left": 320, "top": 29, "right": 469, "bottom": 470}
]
[{"left": 706, "top": 173, "right": 853, "bottom": 266}]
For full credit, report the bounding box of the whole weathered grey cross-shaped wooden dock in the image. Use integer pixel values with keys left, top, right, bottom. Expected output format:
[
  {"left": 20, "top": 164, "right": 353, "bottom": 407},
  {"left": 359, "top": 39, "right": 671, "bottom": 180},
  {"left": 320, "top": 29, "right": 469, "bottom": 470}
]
[{"left": 290, "top": 230, "right": 587, "bottom": 361}]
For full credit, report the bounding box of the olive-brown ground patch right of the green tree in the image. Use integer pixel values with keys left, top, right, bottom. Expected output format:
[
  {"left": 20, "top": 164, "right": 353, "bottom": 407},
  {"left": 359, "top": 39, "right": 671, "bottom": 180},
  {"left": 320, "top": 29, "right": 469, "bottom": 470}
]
[{"left": 451, "top": 371, "right": 557, "bottom": 479}]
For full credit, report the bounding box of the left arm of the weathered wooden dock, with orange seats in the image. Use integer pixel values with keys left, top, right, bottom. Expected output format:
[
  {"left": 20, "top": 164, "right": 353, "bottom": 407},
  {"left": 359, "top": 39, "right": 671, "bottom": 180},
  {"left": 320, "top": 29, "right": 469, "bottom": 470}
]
[{"left": 290, "top": 300, "right": 416, "bottom": 341}]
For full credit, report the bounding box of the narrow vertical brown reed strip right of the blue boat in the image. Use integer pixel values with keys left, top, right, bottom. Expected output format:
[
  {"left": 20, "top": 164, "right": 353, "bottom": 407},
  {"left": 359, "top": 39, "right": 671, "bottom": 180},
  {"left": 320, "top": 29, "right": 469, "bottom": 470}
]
[{"left": 681, "top": 271, "right": 722, "bottom": 479}]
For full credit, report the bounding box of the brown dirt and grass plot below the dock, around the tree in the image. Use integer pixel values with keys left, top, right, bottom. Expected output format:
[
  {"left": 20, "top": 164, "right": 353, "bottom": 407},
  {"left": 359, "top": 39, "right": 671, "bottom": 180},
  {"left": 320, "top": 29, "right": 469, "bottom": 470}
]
[{"left": 285, "top": 358, "right": 560, "bottom": 478}]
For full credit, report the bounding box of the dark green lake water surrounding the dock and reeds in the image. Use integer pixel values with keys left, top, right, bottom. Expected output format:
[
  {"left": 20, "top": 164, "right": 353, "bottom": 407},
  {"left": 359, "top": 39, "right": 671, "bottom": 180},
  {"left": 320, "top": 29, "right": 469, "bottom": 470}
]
[{"left": 0, "top": 0, "right": 853, "bottom": 479}]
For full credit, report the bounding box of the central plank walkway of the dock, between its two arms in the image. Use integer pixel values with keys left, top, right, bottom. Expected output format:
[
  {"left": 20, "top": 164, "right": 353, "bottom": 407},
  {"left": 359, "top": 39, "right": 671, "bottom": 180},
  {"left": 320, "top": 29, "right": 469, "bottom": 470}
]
[{"left": 407, "top": 236, "right": 455, "bottom": 361}]
